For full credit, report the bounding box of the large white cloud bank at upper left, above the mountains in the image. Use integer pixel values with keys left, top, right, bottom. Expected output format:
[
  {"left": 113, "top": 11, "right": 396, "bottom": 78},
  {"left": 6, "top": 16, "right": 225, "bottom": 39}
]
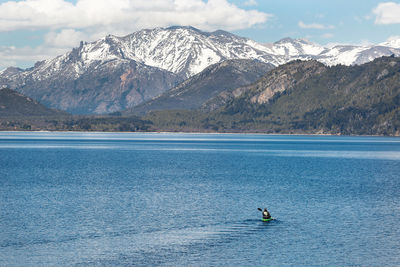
[{"left": 0, "top": 0, "right": 272, "bottom": 70}]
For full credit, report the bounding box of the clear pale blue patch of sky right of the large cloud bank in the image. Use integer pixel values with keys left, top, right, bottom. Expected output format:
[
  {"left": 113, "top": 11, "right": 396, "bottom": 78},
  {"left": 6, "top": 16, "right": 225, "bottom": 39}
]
[{"left": 232, "top": 0, "right": 400, "bottom": 44}]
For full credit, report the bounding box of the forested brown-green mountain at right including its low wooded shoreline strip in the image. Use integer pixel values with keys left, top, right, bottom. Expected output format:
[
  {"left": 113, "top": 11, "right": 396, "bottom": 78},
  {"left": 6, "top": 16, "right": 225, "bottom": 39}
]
[{"left": 146, "top": 57, "right": 400, "bottom": 135}]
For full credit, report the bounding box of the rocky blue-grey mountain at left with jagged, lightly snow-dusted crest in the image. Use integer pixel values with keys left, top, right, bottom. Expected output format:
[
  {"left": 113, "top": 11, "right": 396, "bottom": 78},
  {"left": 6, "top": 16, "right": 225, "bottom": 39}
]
[{"left": 0, "top": 49, "right": 182, "bottom": 114}]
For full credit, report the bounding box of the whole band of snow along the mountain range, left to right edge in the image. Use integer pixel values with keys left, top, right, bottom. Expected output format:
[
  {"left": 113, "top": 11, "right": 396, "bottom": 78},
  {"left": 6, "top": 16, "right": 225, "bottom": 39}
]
[{"left": 6, "top": 27, "right": 400, "bottom": 80}]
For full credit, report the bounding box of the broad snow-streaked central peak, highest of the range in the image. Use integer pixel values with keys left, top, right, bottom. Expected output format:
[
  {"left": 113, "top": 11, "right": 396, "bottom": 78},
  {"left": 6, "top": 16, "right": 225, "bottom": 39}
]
[{"left": 123, "top": 26, "right": 277, "bottom": 78}]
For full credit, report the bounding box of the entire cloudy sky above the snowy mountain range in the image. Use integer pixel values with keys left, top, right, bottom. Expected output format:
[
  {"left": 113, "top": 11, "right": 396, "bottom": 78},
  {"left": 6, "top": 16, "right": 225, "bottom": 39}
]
[{"left": 0, "top": 0, "right": 400, "bottom": 70}]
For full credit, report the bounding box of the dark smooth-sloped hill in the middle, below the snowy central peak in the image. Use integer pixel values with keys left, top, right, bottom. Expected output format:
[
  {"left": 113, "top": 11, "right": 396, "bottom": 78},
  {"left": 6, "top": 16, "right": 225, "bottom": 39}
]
[{"left": 130, "top": 59, "right": 274, "bottom": 114}]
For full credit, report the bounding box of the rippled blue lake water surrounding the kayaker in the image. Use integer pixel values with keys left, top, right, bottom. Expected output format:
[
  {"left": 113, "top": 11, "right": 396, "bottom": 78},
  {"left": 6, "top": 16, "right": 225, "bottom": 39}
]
[{"left": 0, "top": 132, "right": 400, "bottom": 266}]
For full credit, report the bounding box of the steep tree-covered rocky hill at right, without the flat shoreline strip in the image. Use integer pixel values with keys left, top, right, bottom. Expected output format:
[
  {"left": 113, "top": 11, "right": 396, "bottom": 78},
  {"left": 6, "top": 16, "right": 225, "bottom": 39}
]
[{"left": 221, "top": 57, "right": 400, "bottom": 135}]
